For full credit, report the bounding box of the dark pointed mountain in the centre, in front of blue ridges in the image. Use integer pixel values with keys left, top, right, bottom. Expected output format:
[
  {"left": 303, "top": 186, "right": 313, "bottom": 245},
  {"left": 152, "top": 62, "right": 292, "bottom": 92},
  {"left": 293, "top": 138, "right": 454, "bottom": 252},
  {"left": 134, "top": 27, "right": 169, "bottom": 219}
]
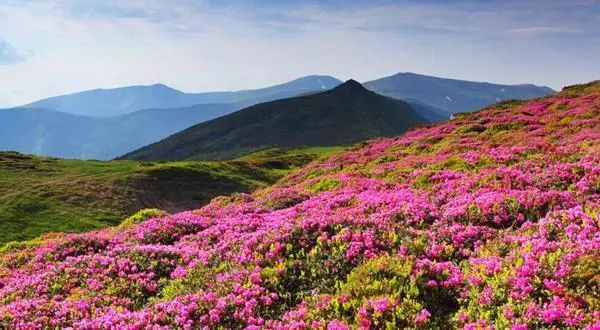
[{"left": 121, "top": 80, "right": 428, "bottom": 160}]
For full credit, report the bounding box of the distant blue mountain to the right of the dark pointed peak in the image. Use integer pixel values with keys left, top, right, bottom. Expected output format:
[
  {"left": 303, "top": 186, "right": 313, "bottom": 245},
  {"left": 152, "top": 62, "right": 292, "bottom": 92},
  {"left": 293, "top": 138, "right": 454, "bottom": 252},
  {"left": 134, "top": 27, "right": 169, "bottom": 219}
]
[{"left": 364, "top": 72, "right": 555, "bottom": 114}]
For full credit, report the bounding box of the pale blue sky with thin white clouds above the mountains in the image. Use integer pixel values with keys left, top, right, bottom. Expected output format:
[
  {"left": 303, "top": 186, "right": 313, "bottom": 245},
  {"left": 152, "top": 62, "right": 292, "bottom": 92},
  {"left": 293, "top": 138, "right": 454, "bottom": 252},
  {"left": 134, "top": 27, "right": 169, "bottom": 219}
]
[{"left": 0, "top": 0, "right": 600, "bottom": 107}]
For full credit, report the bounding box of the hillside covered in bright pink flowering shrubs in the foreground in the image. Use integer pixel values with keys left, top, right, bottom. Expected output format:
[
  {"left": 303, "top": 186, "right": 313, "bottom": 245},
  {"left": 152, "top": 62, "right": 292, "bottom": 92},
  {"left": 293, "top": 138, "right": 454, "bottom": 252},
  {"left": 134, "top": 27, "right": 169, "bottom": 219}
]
[{"left": 0, "top": 83, "right": 600, "bottom": 329}]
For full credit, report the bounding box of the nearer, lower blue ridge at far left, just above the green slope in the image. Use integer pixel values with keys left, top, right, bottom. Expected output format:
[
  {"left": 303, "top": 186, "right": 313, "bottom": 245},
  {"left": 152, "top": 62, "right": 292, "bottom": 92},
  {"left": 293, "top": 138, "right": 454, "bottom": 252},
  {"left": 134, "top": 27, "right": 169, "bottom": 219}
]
[{"left": 0, "top": 104, "right": 241, "bottom": 160}]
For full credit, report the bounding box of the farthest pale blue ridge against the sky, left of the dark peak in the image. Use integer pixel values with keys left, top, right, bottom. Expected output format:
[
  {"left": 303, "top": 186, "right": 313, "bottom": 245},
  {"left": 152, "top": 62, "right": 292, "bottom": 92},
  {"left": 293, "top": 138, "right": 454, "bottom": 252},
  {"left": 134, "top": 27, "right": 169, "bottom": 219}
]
[{"left": 19, "top": 75, "right": 341, "bottom": 117}]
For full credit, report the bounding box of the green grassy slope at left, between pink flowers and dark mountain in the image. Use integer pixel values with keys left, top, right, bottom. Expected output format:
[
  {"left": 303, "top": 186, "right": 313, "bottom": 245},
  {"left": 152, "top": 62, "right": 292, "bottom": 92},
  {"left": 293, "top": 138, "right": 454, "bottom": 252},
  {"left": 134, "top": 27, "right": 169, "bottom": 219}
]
[{"left": 0, "top": 147, "right": 341, "bottom": 244}]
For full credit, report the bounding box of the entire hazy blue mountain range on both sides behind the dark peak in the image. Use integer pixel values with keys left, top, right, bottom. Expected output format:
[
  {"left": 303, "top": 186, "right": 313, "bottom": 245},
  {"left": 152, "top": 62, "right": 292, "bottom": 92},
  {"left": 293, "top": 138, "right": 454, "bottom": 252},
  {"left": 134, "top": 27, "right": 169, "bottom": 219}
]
[{"left": 0, "top": 73, "right": 553, "bottom": 160}]
